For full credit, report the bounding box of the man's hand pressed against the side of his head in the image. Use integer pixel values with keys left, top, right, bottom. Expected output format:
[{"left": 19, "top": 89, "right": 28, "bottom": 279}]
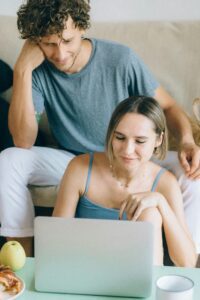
[{"left": 15, "top": 40, "right": 45, "bottom": 72}]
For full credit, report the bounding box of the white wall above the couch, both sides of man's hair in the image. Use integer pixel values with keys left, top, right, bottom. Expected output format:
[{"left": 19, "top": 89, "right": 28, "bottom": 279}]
[{"left": 0, "top": 0, "right": 200, "bottom": 21}]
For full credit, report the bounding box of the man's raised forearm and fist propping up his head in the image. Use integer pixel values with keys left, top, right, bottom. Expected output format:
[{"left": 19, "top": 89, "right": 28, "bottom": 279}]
[{"left": 9, "top": 40, "right": 44, "bottom": 148}]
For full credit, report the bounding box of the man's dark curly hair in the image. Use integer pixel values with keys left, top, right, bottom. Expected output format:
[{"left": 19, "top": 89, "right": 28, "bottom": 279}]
[{"left": 17, "top": 0, "right": 90, "bottom": 41}]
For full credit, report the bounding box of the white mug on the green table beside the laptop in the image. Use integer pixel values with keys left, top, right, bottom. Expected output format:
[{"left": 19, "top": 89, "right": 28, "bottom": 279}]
[{"left": 156, "top": 275, "right": 194, "bottom": 300}]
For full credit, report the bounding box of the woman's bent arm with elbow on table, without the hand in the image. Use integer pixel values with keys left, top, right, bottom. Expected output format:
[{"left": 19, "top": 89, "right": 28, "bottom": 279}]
[{"left": 158, "top": 172, "right": 197, "bottom": 267}]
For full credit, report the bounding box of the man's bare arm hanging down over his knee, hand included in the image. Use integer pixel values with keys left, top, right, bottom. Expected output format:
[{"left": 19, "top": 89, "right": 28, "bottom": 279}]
[{"left": 155, "top": 87, "right": 200, "bottom": 179}]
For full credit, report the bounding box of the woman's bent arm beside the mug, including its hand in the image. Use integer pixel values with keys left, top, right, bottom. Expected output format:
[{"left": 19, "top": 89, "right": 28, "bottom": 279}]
[{"left": 120, "top": 172, "right": 197, "bottom": 267}]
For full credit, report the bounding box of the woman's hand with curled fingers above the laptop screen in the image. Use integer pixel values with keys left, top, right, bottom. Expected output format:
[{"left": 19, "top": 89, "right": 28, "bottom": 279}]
[{"left": 119, "top": 192, "right": 164, "bottom": 221}]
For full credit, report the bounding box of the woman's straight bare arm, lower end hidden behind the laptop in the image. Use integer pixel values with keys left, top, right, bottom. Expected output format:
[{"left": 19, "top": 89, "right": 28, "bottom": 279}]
[{"left": 53, "top": 155, "right": 89, "bottom": 218}]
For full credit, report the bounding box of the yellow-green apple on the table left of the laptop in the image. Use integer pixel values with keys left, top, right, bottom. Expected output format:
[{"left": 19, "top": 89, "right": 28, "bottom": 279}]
[{"left": 0, "top": 241, "right": 26, "bottom": 271}]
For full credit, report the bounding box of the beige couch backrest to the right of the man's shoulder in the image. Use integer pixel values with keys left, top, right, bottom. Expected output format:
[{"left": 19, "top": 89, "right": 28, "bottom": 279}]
[{"left": 87, "top": 21, "right": 200, "bottom": 114}]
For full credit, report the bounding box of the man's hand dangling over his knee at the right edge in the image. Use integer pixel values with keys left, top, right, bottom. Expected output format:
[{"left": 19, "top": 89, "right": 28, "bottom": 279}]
[{"left": 178, "top": 143, "right": 200, "bottom": 180}]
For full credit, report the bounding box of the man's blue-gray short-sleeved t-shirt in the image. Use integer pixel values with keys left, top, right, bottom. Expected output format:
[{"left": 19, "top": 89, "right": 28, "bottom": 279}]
[{"left": 33, "top": 39, "right": 158, "bottom": 153}]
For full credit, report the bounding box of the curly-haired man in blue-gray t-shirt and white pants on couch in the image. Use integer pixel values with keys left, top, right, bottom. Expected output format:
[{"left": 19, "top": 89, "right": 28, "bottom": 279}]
[{"left": 0, "top": 0, "right": 200, "bottom": 255}]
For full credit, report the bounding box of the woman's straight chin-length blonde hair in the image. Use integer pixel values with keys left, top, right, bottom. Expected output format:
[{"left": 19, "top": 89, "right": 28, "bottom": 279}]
[{"left": 106, "top": 96, "right": 168, "bottom": 163}]
